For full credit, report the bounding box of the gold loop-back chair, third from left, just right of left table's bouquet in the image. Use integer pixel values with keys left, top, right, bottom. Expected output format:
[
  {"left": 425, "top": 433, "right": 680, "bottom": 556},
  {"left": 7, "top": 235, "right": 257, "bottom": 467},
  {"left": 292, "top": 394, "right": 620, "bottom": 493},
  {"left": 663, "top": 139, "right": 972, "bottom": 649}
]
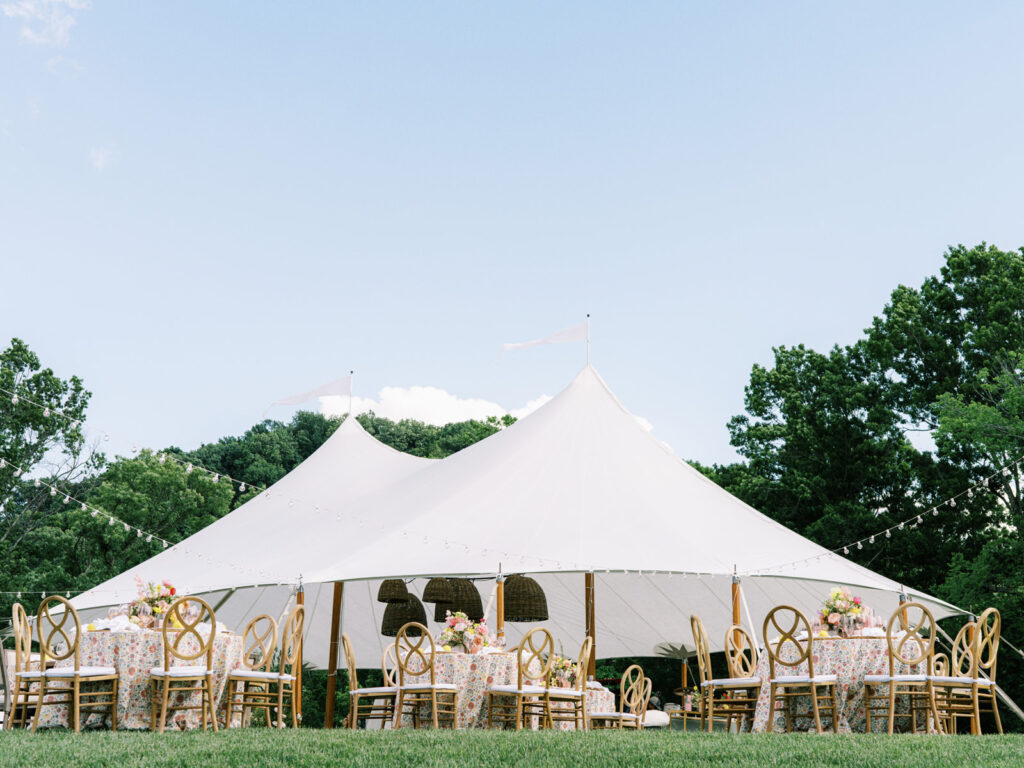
[{"left": 150, "top": 597, "right": 217, "bottom": 733}]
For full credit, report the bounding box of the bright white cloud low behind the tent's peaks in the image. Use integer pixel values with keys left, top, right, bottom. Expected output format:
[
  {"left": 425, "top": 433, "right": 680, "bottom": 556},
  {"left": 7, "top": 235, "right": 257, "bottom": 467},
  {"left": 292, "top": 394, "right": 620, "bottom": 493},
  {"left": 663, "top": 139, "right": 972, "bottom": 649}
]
[{"left": 319, "top": 386, "right": 653, "bottom": 432}]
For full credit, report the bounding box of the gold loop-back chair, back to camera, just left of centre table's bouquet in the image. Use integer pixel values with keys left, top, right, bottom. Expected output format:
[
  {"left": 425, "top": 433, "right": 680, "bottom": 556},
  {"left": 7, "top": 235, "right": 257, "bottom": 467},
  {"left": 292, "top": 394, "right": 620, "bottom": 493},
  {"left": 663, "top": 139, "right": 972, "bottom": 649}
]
[{"left": 394, "top": 622, "right": 459, "bottom": 728}]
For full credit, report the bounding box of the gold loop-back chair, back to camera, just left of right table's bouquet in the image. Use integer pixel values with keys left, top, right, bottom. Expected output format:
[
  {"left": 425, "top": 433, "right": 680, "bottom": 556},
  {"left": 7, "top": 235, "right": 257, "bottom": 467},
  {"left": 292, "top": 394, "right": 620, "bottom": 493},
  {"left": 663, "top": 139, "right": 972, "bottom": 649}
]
[{"left": 762, "top": 605, "right": 839, "bottom": 733}]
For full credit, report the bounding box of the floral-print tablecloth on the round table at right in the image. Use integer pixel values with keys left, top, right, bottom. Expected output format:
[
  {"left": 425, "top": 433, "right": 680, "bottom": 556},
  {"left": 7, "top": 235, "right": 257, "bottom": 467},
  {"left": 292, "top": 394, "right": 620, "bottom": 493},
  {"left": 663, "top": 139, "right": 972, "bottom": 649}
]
[{"left": 753, "top": 637, "right": 918, "bottom": 733}]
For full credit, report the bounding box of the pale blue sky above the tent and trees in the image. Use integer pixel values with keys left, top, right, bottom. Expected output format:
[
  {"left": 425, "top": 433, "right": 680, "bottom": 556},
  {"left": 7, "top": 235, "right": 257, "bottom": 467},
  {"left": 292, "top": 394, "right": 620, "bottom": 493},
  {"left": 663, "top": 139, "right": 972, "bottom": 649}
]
[{"left": 0, "top": 0, "right": 1024, "bottom": 462}]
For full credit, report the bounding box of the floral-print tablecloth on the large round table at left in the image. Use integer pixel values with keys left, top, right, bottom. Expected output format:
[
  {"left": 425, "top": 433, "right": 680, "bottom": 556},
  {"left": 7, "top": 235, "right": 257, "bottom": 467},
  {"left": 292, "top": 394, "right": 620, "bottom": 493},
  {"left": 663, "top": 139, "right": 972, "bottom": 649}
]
[{"left": 39, "top": 630, "right": 243, "bottom": 730}]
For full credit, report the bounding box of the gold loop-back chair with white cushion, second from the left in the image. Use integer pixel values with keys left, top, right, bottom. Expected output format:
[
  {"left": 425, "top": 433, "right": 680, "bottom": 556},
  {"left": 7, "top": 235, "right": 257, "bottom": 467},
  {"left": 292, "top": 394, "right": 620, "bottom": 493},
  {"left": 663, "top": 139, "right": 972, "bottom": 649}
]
[{"left": 32, "top": 595, "right": 118, "bottom": 733}]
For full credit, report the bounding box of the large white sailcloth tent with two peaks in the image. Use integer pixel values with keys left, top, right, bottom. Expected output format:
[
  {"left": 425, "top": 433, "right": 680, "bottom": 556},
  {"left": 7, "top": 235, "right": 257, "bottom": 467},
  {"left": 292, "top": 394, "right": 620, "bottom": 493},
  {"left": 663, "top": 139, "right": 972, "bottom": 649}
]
[{"left": 73, "top": 366, "right": 963, "bottom": 724}]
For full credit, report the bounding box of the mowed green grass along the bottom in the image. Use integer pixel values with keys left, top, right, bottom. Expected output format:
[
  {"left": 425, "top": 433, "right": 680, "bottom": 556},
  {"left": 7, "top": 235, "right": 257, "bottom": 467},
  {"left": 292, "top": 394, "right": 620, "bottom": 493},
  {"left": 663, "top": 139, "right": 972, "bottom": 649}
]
[{"left": 0, "top": 728, "right": 1024, "bottom": 768}]
